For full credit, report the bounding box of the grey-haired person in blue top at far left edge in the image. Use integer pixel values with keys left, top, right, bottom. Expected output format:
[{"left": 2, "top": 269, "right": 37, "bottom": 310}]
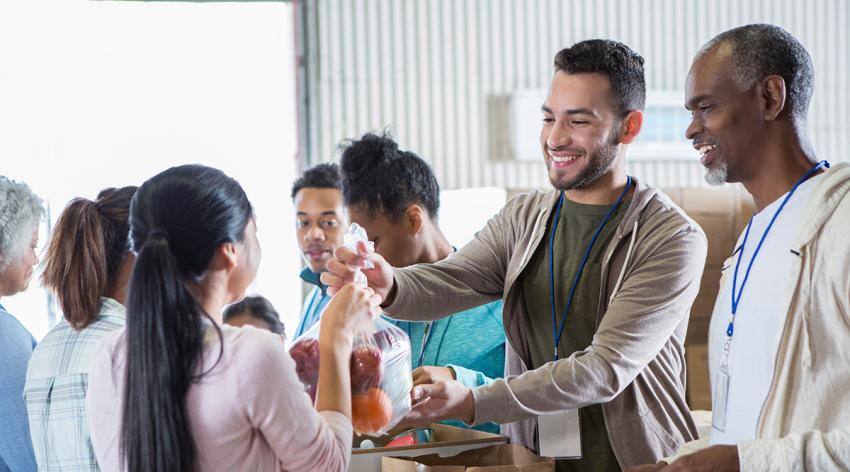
[{"left": 0, "top": 176, "right": 44, "bottom": 472}]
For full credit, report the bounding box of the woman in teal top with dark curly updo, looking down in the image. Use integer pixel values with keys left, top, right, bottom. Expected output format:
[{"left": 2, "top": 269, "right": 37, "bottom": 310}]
[{"left": 340, "top": 134, "right": 505, "bottom": 432}]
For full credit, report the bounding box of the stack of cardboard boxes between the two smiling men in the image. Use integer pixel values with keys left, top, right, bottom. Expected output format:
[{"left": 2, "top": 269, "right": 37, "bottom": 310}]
[{"left": 665, "top": 185, "right": 754, "bottom": 410}]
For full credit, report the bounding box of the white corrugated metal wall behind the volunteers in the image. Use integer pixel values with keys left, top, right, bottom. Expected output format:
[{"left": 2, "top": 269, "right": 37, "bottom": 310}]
[{"left": 297, "top": 0, "right": 850, "bottom": 188}]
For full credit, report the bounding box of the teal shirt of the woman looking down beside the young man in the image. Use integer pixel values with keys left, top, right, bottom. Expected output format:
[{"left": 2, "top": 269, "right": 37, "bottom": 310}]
[{"left": 389, "top": 300, "right": 505, "bottom": 433}]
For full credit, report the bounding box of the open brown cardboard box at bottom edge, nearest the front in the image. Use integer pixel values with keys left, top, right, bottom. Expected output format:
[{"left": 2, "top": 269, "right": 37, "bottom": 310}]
[{"left": 381, "top": 445, "right": 555, "bottom": 472}]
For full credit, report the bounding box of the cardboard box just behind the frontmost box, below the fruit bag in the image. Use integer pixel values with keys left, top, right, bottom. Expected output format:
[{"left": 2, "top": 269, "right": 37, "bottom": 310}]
[{"left": 349, "top": 424, "right": 508, "bottom": 472}]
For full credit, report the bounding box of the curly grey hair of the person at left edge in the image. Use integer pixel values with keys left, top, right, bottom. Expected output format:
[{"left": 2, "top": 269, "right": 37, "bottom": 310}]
[{"left": 0, "top": 175, "right": 44, "bottom": 270}]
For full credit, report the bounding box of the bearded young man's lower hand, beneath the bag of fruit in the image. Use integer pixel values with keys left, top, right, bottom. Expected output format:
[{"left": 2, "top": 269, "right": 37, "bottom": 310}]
[{"left": 402, "top": 380, "right": 475, "bottom": 428}]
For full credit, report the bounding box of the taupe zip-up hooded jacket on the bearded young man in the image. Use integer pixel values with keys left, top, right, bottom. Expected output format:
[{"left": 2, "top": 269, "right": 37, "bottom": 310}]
[{"left": 385, "top": 179, "right": 707, "bottom": 467}]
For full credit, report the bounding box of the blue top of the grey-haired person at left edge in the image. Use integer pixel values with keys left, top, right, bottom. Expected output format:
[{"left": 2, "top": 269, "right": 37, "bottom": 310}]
[{"left": 0, "top": 313, "right": 37, "bottom": 472}]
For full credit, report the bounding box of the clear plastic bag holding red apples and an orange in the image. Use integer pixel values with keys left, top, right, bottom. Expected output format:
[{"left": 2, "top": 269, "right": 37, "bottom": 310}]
[{"left": 289, "top": 223, "right": 413, "bottom": 435}]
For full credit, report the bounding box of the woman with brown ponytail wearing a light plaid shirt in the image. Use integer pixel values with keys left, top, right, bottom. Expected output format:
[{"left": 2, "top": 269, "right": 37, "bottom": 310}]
[{"left": 24, "top": 187, "right": 136, "bottom": 471}]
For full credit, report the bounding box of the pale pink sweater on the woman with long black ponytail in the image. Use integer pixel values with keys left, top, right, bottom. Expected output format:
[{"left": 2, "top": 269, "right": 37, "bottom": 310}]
[{"left": 86, "top": 326, "right": 352, "bottom": 472}]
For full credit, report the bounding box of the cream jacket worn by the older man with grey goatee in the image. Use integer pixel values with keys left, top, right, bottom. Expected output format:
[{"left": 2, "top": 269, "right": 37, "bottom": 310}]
[{"left": 720, "top": 163, "right": 850, "bottom": 471}]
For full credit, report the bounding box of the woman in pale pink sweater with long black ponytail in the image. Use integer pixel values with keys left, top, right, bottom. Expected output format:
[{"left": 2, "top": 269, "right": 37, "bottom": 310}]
[{"left": 87, "top": 165, "right": 380, "bottom": 472}]
